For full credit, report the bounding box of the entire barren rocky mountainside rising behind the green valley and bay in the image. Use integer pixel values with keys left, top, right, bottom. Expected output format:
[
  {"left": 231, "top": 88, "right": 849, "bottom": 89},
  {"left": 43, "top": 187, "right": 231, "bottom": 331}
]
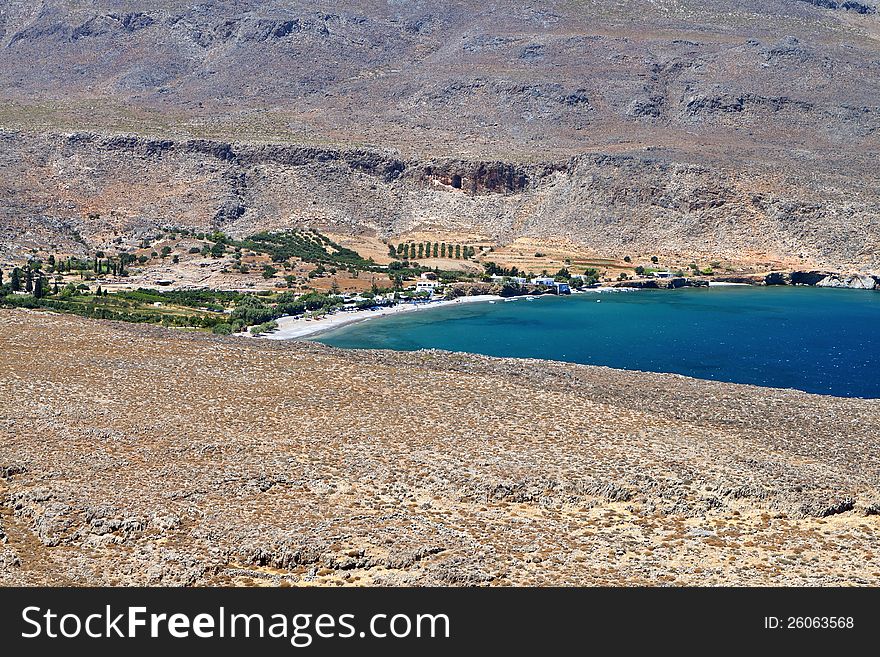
[{"left": 0, "top": 0, "right": 880, "bottom": 269}]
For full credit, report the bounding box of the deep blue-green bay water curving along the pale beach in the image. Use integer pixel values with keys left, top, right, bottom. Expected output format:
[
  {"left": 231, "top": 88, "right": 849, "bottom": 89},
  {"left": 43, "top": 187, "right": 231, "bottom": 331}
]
[{"left": 317, "top": 287, "right": 880, "bottom": 398}]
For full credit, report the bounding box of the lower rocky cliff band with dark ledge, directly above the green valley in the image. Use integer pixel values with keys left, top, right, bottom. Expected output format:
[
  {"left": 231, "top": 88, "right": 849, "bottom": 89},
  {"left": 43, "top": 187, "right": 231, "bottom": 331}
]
[{"left": 0, "top": 133, "right": 880, "bottom": 269}]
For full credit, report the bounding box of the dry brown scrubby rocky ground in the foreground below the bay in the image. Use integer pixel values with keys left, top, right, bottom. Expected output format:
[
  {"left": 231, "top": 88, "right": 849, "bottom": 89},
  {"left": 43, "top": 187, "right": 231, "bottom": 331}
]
[{"left": 0, "top": 311, "right": 880, "bottom": 586}]
